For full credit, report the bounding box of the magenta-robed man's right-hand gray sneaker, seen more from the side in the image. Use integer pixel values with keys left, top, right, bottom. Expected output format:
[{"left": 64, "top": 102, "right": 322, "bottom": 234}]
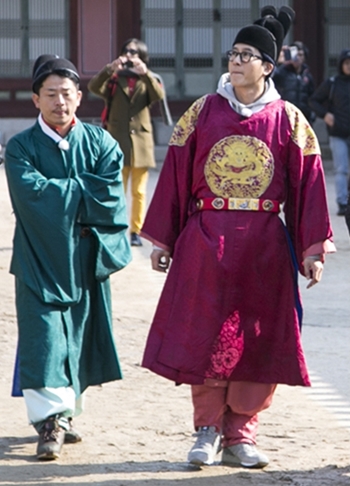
[{"left": 221, "top": 443, "right": 269, "bottom": 468}]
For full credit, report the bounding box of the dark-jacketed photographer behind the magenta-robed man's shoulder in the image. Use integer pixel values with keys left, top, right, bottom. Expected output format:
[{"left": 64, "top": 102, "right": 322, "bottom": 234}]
[{"left": 273, "top": 41, "right": 315, "bottom": 123}]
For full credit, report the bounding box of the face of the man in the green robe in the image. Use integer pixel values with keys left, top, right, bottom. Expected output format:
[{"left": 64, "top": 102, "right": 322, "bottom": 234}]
[{"left": 32, "top": 74, "right": 82, "bottom": 129}]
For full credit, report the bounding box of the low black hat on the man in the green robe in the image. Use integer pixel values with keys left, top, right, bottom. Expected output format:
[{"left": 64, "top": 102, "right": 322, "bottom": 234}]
[{"left": 32, "top": 54, "right": 80, "bottom": 94}]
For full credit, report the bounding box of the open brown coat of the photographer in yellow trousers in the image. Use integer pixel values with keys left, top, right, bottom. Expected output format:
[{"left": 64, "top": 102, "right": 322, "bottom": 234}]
[{"left": 88, "top": 66, "right": 164, "bottom": 167}]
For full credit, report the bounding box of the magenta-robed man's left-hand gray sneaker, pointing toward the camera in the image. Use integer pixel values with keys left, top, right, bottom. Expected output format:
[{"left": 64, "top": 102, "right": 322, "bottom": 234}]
[{"left": 187, "top": 427, "right": 221, "bottom": 466}]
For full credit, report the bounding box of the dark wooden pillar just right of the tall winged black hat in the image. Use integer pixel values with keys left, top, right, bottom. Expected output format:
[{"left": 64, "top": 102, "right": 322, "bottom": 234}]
[{"left": 293, "top": 0, "right": 325, "bottom": 86}]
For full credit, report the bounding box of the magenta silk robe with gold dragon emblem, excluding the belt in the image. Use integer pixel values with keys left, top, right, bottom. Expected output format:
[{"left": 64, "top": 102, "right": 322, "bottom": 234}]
[{"left": 142, "top": 94, "right": 332, "bottom": 386}]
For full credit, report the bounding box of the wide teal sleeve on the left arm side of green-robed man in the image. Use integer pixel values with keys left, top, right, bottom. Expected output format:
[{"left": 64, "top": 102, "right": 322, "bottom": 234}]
[{"left": 5, "top": 137, "right": 82, "bottom": 305}]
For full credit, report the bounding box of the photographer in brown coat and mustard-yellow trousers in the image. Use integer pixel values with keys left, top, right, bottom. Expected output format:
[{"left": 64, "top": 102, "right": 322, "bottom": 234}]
[{"left": 88, "top": 38, "right": 165, "bottom": 246}]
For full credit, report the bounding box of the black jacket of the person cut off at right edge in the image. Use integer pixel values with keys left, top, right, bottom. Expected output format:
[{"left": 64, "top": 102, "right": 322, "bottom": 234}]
[{"left": 309, "top": 74, "right": 350, "bottom": 138}]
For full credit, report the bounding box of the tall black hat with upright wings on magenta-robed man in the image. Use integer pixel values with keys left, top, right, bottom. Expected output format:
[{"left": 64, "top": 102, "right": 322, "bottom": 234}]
[{"left": 233, "top": 5, "right": 295, "bottom": 63}]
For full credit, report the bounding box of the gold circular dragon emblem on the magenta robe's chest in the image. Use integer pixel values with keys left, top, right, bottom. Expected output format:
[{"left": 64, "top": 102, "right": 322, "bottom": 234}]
[{"left": 204, "top": 135, "right": 275, "bottom": 198}]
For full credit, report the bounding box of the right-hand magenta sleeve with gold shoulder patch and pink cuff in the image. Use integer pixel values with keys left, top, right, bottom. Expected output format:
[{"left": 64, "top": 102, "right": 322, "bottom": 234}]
[{"left": 284, "top": 103, "right": 335, "bottom": 273}]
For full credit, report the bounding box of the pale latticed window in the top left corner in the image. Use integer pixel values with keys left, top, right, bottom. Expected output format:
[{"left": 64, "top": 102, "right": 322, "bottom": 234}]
[{"left": 0, "top": 0, "right": 69, "bottom": 78}]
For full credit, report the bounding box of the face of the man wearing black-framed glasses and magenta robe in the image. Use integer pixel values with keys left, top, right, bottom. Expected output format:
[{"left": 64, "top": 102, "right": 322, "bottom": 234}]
[{"left": 228, "top": 44, "right": 273, "bottom": 88}]
